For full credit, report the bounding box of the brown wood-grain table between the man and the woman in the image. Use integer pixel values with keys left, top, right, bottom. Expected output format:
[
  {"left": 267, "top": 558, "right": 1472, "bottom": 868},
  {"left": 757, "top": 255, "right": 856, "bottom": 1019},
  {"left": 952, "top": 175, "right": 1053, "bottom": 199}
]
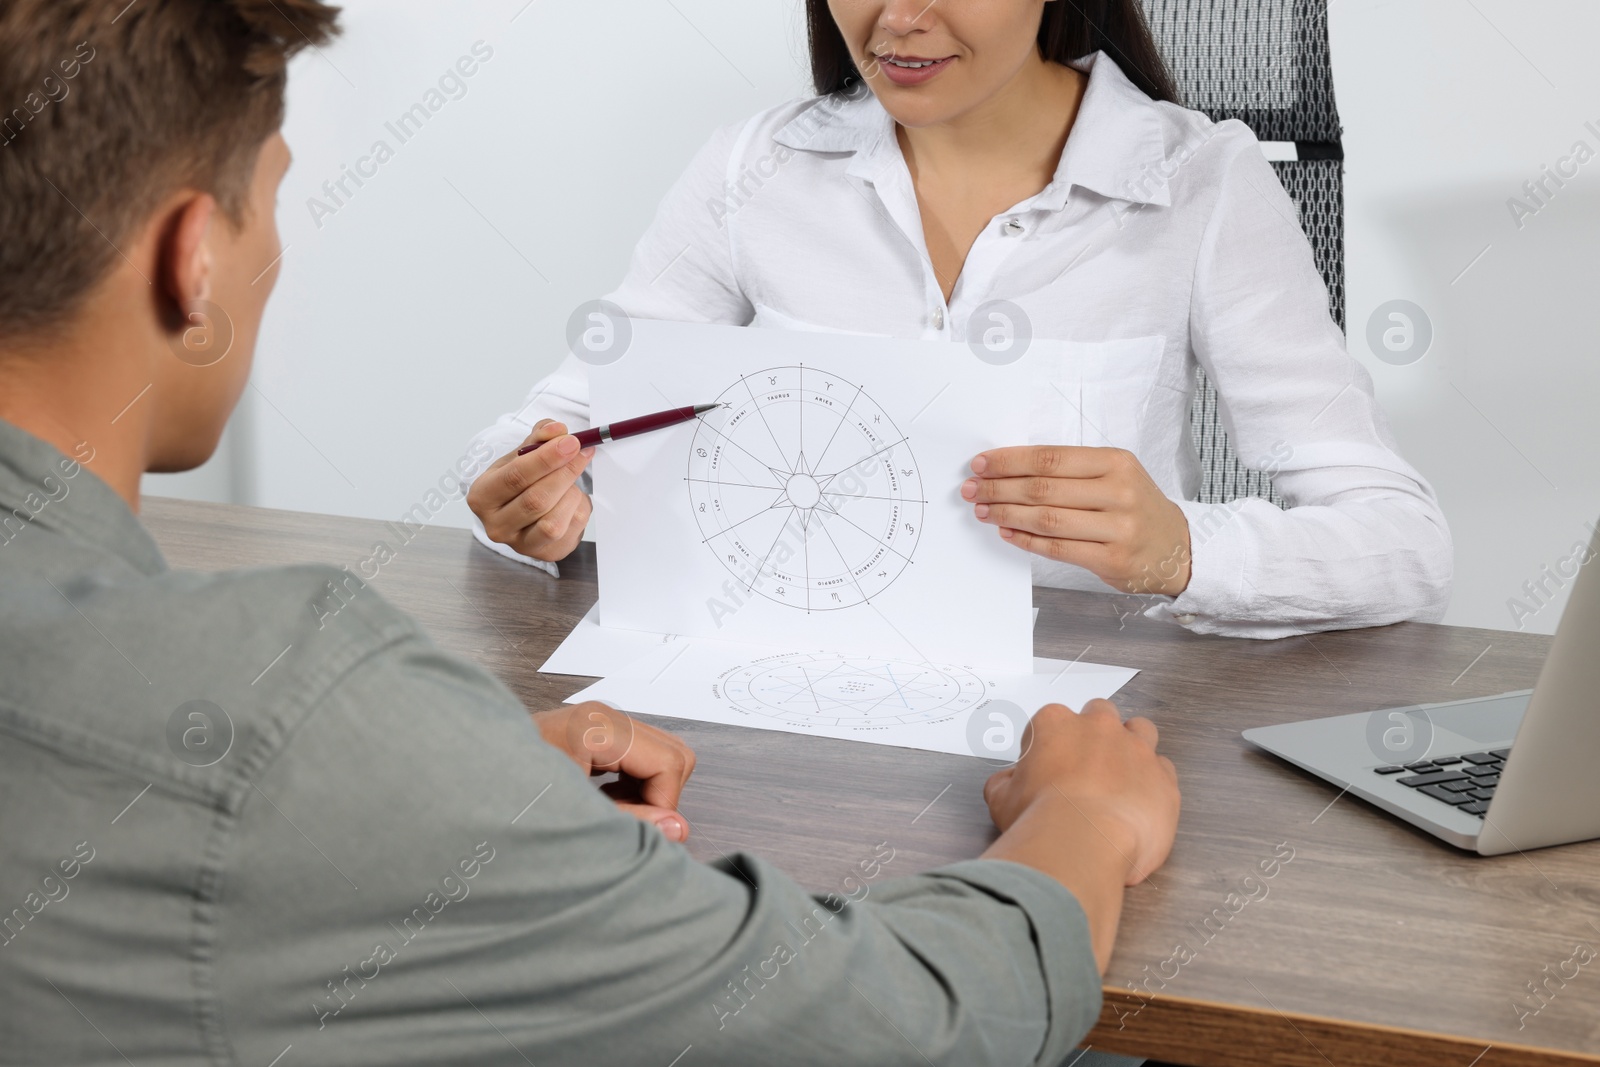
[{"left": 146, "top": 499, "right": 1600, "bottom": 1067}]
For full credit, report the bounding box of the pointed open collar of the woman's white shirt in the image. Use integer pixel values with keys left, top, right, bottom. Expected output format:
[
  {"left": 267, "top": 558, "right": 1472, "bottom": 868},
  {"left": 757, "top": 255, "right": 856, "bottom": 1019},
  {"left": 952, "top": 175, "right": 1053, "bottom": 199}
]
[{"left": 773, "top": 53, "right": 1171, "bottom": 211}]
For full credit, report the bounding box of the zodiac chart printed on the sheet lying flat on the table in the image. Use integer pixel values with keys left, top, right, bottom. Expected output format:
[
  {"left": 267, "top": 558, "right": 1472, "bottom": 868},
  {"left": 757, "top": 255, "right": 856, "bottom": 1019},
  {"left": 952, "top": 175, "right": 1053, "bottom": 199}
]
[{"left": 717, "top": 653, "right": 987, "bottom": 726}]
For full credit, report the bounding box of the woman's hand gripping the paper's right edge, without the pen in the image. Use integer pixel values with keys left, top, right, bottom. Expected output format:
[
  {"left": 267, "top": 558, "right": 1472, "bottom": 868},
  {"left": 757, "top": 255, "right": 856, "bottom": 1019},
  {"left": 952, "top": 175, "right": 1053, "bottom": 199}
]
[{"left": 962, "top": 445, "right": 1190, "bottom": 597}]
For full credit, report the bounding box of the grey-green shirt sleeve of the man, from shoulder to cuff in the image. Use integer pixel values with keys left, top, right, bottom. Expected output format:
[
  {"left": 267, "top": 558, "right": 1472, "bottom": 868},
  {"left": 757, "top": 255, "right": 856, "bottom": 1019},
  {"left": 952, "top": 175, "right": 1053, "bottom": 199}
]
[{"left": 219, "top": 637, "right": 1099, "bottom": 1067}]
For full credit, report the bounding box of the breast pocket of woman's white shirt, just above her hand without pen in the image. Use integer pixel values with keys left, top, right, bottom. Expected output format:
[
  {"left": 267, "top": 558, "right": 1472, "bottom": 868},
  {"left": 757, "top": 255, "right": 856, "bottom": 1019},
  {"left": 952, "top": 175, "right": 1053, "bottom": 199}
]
[{"left": 1029, "top": 334, "right": 1166, "bottom": 453}]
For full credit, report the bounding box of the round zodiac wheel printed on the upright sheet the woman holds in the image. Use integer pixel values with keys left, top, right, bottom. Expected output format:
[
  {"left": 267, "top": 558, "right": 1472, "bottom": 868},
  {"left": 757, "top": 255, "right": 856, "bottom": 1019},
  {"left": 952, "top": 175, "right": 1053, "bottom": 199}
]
[{"left": 686, "top": 366, "right": 926, "bottom": 611}]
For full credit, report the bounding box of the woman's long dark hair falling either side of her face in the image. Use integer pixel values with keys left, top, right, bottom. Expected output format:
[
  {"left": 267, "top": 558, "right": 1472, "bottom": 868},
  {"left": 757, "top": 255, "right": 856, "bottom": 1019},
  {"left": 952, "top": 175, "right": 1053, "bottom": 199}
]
[{"left": 805, "top": 0, "right": 1178, "bottom": 104}]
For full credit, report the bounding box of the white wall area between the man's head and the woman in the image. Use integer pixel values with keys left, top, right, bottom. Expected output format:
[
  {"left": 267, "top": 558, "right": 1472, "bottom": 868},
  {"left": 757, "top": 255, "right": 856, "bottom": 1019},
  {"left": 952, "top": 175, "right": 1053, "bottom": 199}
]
[{"left": 147, "top": 0, "right": 805, "bottom": 525}]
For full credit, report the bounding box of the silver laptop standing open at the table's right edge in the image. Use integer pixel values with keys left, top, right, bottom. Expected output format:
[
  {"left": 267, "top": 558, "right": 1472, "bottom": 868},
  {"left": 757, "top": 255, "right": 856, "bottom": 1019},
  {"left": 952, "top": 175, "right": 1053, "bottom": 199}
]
[{"left": 1245, "top": 530, "right": 1600, "bottom": 856}]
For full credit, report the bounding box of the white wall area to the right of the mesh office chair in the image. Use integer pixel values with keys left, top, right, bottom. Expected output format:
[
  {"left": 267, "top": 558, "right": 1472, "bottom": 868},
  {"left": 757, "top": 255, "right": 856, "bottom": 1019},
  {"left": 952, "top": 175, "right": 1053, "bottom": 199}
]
[{"left": 1330, "top": 0, "right": 1600, "bottom": 633}]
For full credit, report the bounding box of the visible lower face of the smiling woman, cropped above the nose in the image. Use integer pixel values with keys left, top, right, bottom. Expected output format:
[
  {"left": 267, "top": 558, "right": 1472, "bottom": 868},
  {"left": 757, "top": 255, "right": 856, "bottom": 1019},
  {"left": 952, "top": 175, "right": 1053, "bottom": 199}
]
[{"left": 827, "top": 0, "right": 1061, "bottom": 128}]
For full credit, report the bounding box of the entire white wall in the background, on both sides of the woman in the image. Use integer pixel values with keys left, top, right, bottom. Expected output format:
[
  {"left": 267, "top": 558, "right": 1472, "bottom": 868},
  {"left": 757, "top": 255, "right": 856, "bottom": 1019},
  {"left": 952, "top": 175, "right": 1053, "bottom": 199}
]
[{"left": 150, "top": 0, "right": 1600, "bottom": 632}]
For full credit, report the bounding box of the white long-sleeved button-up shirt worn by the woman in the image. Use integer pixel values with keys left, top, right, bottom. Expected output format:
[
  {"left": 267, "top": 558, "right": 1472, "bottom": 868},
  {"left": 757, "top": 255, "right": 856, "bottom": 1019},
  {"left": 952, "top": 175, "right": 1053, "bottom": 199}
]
[{"left": 477, "top": 53, "right": 1453, "bottom": 637}]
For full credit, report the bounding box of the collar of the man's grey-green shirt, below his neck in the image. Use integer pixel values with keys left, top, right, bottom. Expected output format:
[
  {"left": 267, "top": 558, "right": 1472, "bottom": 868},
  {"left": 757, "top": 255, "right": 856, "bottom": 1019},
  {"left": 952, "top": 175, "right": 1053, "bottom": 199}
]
[{"left": 0, "top": 419, "right": 166, "bottom": 576}]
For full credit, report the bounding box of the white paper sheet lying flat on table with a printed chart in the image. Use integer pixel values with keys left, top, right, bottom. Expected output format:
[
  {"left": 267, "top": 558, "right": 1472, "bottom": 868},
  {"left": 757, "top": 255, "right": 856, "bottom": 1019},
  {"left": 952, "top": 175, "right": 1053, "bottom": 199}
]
[{"left": 566, "top": 638, "right": 1138, "bottom": 761}]
